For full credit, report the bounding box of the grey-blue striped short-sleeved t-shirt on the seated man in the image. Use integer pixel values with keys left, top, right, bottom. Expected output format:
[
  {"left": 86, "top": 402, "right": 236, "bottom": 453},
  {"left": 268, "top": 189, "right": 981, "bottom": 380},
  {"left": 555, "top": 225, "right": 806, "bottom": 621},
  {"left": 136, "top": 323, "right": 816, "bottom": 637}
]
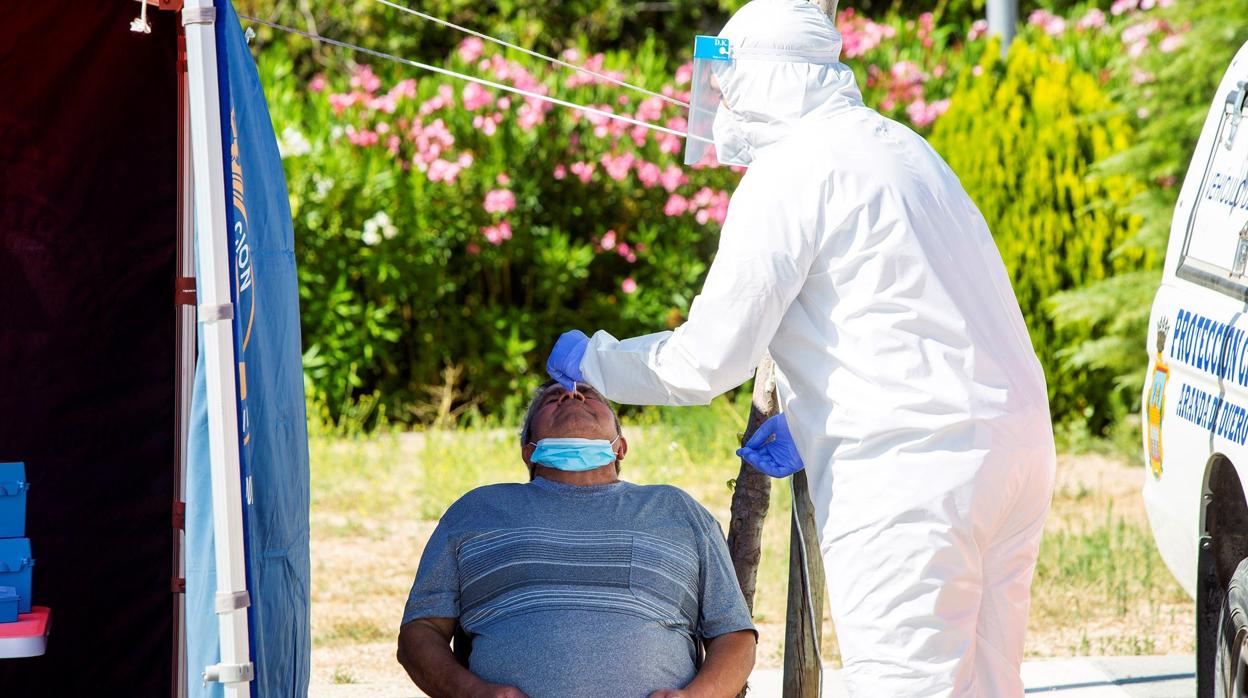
[{"left": 403, "top": 478, "right": 754, "bottom": 698}]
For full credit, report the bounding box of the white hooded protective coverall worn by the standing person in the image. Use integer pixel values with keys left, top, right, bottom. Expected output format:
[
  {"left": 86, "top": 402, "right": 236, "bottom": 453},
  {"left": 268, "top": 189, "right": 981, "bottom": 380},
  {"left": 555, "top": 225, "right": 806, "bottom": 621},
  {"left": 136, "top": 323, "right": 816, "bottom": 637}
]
[{"left": 580, "top": 0, "right": 1056, "bottom": 698}]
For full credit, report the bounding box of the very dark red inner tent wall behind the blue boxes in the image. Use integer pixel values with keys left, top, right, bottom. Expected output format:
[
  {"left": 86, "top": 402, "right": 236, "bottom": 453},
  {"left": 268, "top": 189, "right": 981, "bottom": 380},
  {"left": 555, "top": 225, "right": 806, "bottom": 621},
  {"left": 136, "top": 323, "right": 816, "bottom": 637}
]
[{"left": 0, "top": 0, "right": 178, "bottom": 696}]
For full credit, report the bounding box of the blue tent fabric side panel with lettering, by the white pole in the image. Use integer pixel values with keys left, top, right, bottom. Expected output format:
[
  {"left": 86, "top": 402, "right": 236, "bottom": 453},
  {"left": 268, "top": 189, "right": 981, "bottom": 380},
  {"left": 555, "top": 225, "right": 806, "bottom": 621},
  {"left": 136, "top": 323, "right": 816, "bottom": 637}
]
[{"left": 187, "top": 0, "right": 311, "bottom": 698}]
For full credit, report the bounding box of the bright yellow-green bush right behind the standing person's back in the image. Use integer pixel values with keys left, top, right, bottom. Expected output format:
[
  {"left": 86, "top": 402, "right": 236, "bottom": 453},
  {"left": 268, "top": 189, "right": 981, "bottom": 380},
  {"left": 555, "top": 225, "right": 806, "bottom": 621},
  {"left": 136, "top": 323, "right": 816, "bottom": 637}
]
[{"left": 931, "top": 40, "right": 1144, "bottom": 426}]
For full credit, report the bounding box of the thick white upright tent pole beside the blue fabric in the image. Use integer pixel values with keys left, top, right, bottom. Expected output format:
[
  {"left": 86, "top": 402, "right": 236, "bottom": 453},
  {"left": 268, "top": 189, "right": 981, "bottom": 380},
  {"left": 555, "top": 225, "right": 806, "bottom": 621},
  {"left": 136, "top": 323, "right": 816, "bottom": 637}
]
[{"left": 182, "top": 0, "right": 255, "bottom": 698}]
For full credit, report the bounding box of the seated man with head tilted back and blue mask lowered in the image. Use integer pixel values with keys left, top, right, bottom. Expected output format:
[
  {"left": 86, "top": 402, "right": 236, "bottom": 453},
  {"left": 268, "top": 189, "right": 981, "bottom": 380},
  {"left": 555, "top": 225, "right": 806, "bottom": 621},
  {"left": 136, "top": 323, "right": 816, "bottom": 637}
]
[{"left": 398, "top": 382, "right": 758, "bottom": 698}]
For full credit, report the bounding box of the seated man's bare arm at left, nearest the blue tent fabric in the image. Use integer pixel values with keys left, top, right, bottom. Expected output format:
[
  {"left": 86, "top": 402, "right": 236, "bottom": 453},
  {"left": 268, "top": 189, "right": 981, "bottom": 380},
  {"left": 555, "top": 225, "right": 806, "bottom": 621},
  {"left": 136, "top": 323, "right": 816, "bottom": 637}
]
[{"left": 398, "top": 618, "right": 525, "bottom": 698}]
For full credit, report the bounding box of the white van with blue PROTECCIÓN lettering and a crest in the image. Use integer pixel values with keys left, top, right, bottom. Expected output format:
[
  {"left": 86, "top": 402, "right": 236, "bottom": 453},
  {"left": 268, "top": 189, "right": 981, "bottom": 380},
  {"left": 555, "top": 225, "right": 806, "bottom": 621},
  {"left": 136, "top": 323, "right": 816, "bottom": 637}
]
[{"left": 1141, "top": 44, "right": 1248, "bottom": 698}]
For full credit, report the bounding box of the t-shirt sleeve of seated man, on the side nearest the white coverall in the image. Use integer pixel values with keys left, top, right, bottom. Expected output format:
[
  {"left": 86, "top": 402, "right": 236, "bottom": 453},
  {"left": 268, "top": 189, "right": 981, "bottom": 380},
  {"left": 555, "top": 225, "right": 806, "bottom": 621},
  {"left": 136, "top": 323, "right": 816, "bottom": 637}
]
[{"left": 694, "top": 503, "right": 759, "bottom": 639}]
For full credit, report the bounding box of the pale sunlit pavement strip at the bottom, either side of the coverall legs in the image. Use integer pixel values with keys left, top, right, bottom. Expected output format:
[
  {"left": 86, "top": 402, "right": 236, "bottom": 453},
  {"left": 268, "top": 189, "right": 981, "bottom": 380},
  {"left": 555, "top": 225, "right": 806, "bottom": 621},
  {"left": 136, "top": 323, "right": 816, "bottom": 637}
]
[{"left": 749, "top": 656, "right": 1196, "bottom": 698}]
